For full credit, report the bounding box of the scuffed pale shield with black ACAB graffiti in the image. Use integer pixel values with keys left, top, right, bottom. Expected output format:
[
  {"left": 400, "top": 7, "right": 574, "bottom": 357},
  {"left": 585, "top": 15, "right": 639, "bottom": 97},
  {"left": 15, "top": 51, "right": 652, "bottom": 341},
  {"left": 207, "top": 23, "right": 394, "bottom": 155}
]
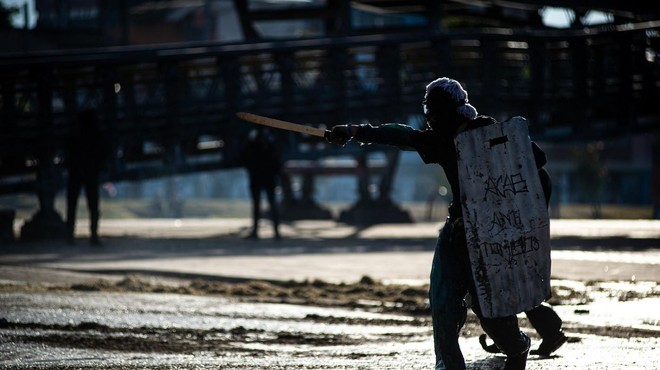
[{"left": 455, "top": 117, "right": 550, "bottom": 318}]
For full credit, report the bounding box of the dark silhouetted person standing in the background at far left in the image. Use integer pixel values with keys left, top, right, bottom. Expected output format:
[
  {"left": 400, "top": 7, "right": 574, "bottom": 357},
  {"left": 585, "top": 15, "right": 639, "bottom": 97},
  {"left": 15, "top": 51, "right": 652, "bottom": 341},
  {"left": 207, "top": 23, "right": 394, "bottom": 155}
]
[{"left": 66, "top": 109, "right": 105, "bottom": 245}]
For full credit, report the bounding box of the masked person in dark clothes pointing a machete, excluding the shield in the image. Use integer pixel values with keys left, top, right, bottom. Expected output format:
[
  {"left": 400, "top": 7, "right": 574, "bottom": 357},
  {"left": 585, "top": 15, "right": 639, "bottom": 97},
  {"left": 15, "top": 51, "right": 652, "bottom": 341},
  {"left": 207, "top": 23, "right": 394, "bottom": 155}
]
[{"left": 326, "top": 77, "right": 545, "bottom": 370}]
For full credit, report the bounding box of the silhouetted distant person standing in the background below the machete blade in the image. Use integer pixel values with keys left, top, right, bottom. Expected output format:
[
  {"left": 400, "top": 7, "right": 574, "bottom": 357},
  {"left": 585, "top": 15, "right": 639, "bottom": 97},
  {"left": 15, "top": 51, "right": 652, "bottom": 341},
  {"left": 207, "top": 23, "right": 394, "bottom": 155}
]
[{"left": 243, "top": 129, "right": 282, "bottom": 239}]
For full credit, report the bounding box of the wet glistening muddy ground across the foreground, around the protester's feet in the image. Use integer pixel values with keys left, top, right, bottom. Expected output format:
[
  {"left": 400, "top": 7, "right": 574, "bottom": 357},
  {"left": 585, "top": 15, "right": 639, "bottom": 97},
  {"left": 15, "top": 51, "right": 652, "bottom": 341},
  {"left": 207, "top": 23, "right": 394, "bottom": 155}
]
[{"left": 0, "top": 276, "right": 660, "bottom": 370}]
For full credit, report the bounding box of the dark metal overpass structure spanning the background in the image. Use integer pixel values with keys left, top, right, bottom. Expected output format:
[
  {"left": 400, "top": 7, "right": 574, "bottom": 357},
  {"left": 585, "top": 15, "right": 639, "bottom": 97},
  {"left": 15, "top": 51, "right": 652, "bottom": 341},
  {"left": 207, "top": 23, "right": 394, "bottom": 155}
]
[{"left": 0, "top": 0, "right": 660, "bottom": 238}]
